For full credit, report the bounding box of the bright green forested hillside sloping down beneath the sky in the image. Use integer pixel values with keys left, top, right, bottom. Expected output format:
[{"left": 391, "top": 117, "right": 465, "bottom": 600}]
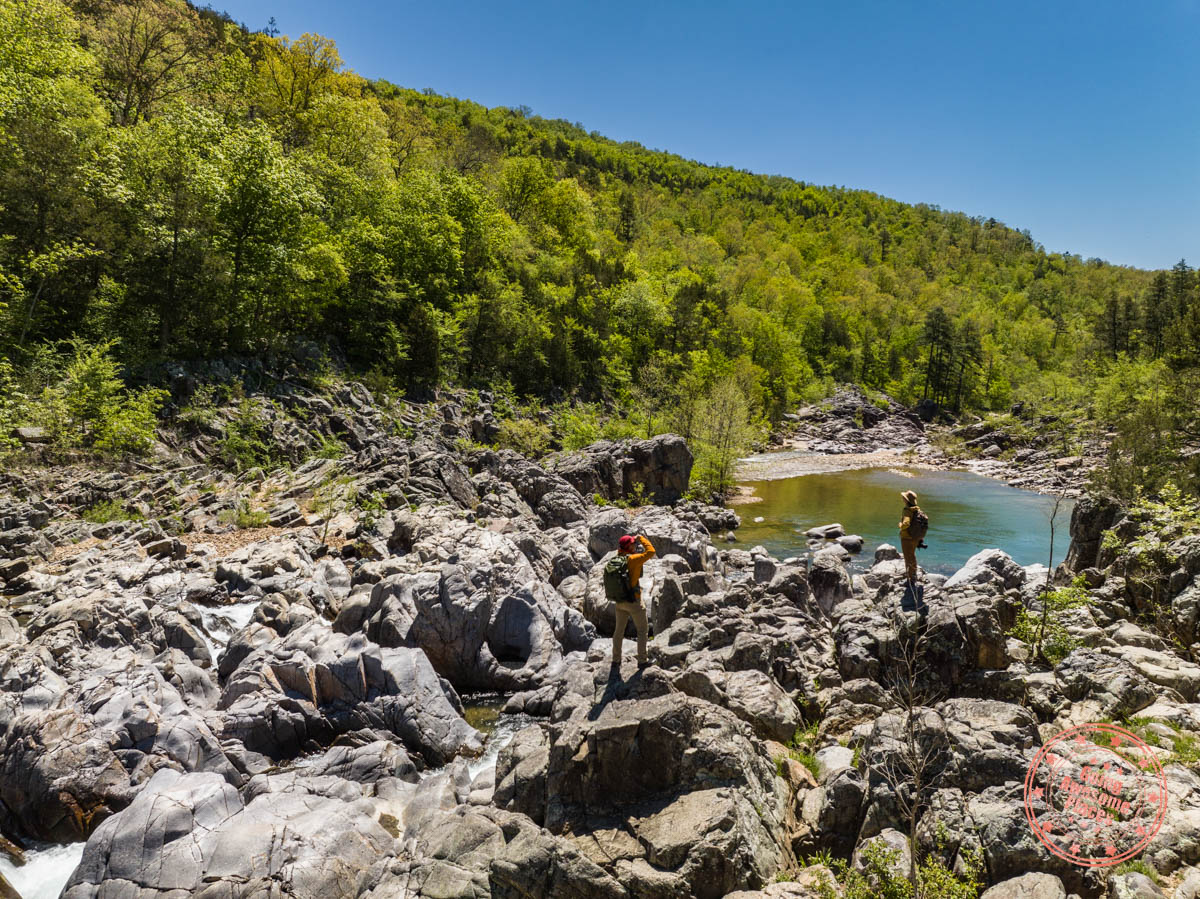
[{"left": 0, "top": 0, "right": 1200, "bottom": 448}]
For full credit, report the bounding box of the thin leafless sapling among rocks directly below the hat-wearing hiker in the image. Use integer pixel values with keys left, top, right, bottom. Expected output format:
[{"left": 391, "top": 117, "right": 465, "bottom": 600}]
[{"left": 868, "top": 625, "right": 949, "bottom": 887}]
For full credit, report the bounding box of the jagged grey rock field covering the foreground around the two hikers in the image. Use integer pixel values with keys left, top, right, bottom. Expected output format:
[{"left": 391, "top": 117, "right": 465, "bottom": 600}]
[{"left": 0, "top": 374, "right": 1200, "bottom": 899}]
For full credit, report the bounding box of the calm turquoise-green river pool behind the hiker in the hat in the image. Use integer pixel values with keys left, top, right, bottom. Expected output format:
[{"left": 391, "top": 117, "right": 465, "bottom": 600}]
[{"left": 736, "top": 468, "right": 1074, "bottom": 574}]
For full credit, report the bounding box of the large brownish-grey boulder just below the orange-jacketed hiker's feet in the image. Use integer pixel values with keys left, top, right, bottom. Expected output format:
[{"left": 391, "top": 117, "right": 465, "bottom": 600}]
[{"left": 497, "top": 693, "right": 788, "bottom": 899}]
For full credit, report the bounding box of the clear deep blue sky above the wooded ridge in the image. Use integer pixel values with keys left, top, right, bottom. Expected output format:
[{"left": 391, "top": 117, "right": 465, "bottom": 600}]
[{"left": 212, "top": 0, "right": 1200, "bottom": 268}]
